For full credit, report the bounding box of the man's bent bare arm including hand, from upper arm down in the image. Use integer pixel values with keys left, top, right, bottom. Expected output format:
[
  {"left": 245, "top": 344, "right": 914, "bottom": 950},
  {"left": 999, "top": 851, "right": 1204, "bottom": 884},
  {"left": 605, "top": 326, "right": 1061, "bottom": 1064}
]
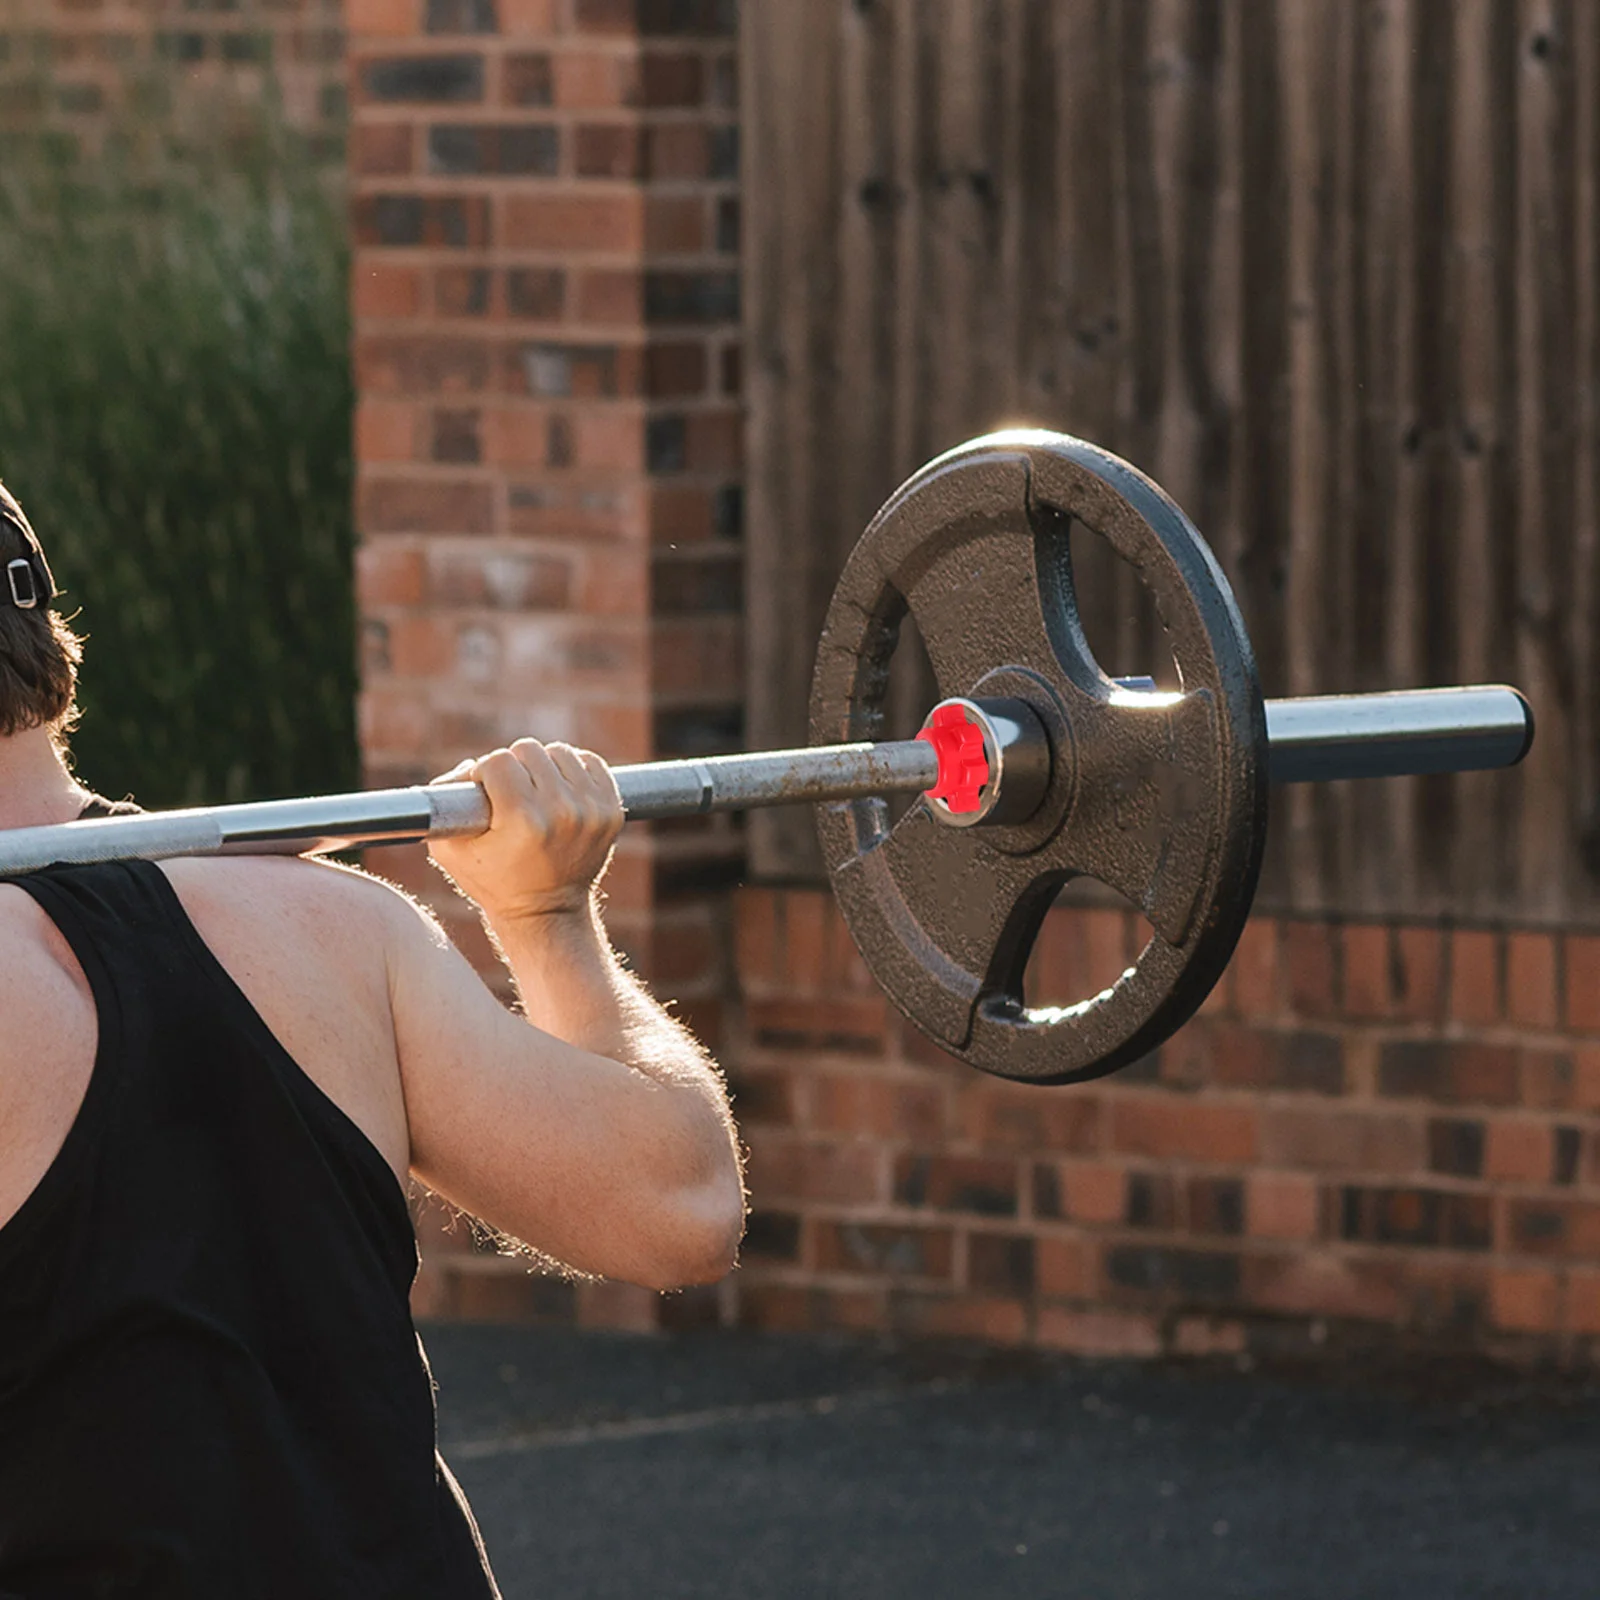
[{"left": 390, "top": 739, "right": 744, "bottom": 1288}]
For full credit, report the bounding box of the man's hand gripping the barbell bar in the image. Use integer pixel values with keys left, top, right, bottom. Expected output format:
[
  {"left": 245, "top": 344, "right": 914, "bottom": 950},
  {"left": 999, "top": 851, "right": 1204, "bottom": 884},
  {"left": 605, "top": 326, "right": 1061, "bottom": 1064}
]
[{"left": 430, "top": 739, "right": 622, "bottom": 925}]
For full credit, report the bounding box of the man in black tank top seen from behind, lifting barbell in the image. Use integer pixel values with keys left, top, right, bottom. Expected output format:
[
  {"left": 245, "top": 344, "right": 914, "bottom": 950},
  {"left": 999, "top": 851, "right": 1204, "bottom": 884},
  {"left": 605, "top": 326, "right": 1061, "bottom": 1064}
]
[{"left": 0, "top": 490, "right": 744, "bottom": 1600}]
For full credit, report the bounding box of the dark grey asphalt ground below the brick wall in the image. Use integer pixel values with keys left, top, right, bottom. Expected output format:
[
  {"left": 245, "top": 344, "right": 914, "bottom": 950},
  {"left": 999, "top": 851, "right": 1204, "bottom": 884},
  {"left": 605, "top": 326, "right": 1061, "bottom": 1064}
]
[{"left": 424, "top": 1326, "right": 1600, "bottom": 1600}]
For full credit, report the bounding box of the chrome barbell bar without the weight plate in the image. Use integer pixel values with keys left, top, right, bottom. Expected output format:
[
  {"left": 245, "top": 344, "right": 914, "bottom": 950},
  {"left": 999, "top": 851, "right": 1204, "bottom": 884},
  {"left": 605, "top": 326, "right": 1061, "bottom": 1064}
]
[{"left": 0, "top": 680, "right": 1533, "bottom": 875}]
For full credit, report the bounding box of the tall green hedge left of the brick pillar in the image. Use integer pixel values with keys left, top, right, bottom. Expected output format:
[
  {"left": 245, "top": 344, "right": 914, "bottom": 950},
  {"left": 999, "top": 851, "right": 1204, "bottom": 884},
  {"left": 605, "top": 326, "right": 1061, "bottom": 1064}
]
[{"left": 0, "top": 130, "right": 358, "bottom": 805}]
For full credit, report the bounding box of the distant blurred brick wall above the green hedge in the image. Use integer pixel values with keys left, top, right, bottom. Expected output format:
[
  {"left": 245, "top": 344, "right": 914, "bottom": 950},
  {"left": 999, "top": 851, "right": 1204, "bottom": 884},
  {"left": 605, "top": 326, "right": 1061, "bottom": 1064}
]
[{"left": 0, "top": 0, "right": 344, "bottom": 160}]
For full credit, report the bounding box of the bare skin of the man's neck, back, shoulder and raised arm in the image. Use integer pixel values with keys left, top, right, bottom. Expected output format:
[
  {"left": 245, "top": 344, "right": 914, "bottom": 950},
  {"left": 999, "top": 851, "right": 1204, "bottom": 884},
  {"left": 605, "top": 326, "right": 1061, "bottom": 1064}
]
[{"left": 0, "top": 728, "right": 744, "bottom": 1288}]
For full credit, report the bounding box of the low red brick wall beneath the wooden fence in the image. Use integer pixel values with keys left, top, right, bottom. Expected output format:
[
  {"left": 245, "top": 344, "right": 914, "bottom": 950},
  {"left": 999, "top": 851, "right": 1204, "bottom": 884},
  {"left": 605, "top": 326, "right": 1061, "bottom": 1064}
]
[{"left": 733, "top": 890, "right": 1600, "bottom": 1358}]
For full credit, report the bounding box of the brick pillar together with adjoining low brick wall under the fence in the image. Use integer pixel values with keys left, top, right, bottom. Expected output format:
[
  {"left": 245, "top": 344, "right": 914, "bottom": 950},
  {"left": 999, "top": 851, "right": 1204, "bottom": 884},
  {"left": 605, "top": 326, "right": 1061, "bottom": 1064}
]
[{"left": 347, "top": 0, "right": 1600, "bottom": 1358}]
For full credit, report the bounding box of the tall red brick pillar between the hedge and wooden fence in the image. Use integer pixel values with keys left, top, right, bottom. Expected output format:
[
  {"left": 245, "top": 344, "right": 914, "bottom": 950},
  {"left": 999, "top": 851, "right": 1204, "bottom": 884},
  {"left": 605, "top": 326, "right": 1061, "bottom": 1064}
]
[{"left": 347, "top": 0, "right": 744, "bottom": 1322}]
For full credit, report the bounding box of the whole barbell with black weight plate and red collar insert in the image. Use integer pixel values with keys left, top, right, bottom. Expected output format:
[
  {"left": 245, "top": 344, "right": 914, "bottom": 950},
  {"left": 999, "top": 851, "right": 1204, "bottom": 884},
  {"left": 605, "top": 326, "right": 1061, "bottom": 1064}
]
[{"left": 0, "top": 430, "right": 1533, "bottom": 1083}]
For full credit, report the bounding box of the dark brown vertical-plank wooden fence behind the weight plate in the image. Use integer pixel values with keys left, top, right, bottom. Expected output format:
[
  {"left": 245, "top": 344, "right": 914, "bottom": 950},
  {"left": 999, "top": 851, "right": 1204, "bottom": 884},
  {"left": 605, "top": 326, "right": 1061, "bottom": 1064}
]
[{"left": 741, "top": 0, "right": 1600, "bottom": 923}]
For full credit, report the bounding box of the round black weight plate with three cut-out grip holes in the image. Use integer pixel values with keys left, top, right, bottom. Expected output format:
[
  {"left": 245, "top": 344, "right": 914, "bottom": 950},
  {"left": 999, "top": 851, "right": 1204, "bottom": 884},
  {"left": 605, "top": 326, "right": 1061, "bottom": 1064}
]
[{"left": 811, "top": 432, "right": 1267, "bottom": 1083}]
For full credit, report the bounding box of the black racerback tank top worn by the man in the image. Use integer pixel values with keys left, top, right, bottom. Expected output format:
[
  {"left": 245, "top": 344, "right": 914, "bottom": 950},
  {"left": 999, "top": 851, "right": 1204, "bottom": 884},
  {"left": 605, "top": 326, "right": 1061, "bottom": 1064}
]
[{"left": 0, "top": 862, "right": 498, "bottom": 1600}]
